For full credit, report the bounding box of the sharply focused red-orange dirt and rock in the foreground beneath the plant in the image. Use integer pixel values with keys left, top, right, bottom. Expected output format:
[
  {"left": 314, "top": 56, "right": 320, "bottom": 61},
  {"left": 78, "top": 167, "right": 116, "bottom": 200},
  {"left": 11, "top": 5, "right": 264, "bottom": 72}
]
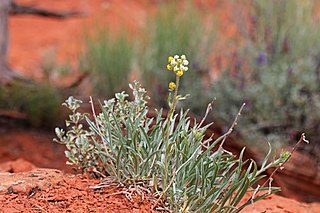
[{"left": 0, "top": 161, "right": 320, "bottom": 213}]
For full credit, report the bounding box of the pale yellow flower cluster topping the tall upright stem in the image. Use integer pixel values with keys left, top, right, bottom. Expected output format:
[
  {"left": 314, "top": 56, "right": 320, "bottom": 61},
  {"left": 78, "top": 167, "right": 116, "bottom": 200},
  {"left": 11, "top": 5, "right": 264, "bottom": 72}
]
[{"left": 167, "top": 55, "right": 189, "bottom": 77}]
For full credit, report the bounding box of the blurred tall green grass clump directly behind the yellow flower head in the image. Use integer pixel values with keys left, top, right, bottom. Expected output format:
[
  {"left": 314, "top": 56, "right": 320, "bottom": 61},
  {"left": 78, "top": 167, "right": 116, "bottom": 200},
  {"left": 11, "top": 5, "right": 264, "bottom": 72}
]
[{"left": 138, "top": 0, "right": 215, "bottom": 107}]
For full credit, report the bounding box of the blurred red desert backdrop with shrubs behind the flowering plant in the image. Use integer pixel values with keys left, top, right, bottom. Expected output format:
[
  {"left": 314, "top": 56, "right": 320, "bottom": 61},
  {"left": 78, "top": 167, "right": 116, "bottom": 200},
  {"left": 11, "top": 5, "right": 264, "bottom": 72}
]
[{"left": 0, "top": 0, "right": 320, "bottom": 202}]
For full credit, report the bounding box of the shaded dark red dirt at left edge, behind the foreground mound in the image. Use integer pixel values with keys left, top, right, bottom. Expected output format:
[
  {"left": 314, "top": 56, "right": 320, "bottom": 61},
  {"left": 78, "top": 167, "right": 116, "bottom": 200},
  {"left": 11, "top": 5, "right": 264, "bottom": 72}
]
[{"left": 0, "top": 126, "right": 73, "bottom": 172}]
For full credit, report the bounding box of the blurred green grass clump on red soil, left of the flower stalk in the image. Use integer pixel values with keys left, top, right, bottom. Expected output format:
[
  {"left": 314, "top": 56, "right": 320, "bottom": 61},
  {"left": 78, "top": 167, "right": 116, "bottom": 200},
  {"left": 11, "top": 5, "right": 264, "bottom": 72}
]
[{"left": 79, "top": 26, "right": 134, "bottom": 97}]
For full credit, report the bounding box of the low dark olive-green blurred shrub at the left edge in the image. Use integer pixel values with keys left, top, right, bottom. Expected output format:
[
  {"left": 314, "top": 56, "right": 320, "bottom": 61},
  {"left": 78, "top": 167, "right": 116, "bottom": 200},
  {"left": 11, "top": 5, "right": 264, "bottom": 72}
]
[{"left": 0, "top": 83, "right": 63, "bottom": 128}]
